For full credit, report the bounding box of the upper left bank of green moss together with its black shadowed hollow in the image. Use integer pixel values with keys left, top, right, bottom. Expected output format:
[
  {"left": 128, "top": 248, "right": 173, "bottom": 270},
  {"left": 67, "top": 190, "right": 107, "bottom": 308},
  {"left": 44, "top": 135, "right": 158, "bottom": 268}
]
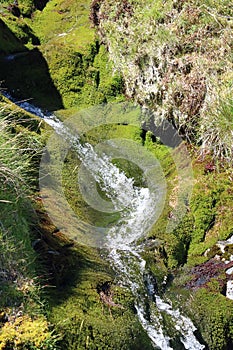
[{"left": 0, "top": 0, "right": 123, "bottom": 110}]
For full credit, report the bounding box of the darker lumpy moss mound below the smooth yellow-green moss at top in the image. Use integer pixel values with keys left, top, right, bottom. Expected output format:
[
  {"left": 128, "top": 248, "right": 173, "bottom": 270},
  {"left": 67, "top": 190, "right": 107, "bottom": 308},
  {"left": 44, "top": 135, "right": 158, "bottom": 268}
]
[{"left": 40, "top": 42, "right": 123, "bottom": 107}]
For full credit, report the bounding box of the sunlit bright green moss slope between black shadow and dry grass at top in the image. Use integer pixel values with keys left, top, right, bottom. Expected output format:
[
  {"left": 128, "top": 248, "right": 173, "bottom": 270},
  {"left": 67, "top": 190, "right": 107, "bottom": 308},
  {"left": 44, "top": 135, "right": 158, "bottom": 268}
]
[{"left": 28, "top": 0, "right": 123, "bottom": 107}]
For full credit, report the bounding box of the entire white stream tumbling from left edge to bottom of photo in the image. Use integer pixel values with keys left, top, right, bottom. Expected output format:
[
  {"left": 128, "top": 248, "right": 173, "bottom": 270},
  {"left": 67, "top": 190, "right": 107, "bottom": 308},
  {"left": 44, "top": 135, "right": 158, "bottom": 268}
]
[{"left": 3, "top": 96, "right": 204, "bottom": 350}]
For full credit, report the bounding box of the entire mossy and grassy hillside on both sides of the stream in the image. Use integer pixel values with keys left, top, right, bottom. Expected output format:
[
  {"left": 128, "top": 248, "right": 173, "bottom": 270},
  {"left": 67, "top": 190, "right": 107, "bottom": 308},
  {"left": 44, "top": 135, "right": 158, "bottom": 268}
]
[{"left": 0, "top": 0, "right": 233, "bottom": 350}]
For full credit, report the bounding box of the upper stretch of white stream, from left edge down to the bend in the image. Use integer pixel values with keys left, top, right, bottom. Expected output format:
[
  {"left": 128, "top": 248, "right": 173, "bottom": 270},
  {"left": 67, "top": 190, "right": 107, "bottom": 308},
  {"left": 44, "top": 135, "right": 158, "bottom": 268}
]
[{"left": 5, "top": 94, "right": 156, "bottom": 249}]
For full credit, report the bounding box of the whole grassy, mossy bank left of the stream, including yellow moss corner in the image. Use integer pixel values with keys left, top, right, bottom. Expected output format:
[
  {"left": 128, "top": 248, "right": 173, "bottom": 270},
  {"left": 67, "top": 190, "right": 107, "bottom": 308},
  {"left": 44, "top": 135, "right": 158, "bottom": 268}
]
[{"left": 0, "top": 99, "right": 152, "bottom": 350}]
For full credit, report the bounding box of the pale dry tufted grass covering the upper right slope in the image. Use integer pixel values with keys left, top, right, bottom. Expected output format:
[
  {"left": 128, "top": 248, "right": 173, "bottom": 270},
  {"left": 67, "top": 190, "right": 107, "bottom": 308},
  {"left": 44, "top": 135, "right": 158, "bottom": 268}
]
[{"left": 91, "top": 0, "right": 233, "bottom": 162}]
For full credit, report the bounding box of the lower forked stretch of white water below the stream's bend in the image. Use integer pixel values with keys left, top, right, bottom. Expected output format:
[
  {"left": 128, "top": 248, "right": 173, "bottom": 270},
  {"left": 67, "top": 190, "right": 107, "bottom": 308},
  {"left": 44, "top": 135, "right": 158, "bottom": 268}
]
[{"left": 109, "top": 249, "right": 205, "bottom": 350}]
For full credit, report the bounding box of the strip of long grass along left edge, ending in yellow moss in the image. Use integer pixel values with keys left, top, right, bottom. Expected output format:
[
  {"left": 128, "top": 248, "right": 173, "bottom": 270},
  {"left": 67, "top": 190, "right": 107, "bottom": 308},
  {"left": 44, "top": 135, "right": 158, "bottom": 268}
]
[{"left": 0, "top": 102, "right": 60, "bottom": 349}]
